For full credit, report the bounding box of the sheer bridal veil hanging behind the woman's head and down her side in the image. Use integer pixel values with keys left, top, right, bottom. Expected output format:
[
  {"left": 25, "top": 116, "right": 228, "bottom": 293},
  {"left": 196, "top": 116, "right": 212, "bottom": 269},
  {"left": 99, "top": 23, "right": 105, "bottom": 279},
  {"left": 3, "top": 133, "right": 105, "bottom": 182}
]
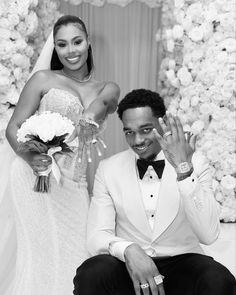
[{"left": 0, "top": 32, "right": 54, "bottom": 295}]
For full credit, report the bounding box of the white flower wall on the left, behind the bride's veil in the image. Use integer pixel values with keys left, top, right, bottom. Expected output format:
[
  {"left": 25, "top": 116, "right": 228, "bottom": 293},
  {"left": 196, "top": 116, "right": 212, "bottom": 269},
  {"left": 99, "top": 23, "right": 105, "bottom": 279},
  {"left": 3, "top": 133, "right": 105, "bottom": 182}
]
[{"left": 0, "top": 0, "right": 60, "bottom": 143}]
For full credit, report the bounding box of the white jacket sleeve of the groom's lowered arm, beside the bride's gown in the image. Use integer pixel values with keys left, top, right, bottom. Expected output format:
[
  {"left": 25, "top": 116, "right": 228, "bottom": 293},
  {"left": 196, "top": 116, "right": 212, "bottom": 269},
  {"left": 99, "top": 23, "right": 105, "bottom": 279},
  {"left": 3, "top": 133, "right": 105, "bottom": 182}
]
[{"left": 87, "top": 161, "right": 133, "bottom": 255}]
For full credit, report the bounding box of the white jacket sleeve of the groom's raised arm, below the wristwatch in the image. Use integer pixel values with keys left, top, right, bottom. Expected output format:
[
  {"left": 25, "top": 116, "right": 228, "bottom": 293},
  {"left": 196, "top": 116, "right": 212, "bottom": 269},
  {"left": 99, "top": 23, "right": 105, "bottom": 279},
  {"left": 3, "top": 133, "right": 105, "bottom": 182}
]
[{"left": 178, "top": 153, "right": 220, "bottom": 244}]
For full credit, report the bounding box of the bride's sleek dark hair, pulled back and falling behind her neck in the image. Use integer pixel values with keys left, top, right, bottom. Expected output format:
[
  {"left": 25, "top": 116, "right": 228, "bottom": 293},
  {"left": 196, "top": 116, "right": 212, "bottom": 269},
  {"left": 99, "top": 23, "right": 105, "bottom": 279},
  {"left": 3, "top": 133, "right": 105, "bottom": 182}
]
[{"left": 50, "top": 15, "right": 94, "bottom": 75}]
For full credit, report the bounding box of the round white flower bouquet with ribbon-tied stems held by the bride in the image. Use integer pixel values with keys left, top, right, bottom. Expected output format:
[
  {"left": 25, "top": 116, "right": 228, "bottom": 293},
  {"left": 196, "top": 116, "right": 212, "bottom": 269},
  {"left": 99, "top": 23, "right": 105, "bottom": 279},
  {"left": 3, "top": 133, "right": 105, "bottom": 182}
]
[{"left": 17, "top": 111, "right": 74, "bottom": 192}]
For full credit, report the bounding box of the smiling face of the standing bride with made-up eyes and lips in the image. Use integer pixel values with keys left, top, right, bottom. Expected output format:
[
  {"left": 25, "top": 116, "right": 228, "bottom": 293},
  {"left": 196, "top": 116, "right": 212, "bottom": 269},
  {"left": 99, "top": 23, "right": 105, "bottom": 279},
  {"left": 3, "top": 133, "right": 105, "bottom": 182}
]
[{"left": 54, "top": 24, "right": 89, "bottom": 70}]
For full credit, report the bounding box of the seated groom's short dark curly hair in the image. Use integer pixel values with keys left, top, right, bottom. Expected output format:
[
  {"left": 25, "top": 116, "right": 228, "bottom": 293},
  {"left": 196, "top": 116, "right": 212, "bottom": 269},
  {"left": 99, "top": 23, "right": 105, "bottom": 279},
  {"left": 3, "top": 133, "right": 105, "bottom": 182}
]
[{"left": 117, "top": 89, "right": 166, "bottom": 120}]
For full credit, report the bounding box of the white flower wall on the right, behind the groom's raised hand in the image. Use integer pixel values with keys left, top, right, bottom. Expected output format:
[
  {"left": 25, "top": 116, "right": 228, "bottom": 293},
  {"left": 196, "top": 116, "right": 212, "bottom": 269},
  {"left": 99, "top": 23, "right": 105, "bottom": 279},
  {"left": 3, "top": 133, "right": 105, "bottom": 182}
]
[{"left": 157, "top": 0, "right": 236, "bottom": 222}]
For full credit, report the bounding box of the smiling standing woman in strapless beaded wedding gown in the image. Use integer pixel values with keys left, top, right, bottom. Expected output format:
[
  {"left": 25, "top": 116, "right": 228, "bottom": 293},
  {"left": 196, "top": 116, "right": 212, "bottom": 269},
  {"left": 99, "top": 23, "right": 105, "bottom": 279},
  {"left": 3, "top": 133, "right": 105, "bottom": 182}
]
[{"left": 0, "top": 15, "right": 119, "bottom": 295}]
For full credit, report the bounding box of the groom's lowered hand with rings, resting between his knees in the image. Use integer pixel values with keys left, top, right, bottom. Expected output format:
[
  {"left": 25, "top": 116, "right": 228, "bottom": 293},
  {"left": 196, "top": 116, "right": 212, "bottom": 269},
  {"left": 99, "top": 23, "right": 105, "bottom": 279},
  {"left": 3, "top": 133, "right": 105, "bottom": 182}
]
[{"left": 124, "top": 244, "right": 165, "bottom": 295}]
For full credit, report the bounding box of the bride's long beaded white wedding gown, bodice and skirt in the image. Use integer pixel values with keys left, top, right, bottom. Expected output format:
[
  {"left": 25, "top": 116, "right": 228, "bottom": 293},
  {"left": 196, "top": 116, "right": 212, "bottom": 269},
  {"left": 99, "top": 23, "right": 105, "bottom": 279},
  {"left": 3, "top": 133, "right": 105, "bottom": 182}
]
[{"left": 6, "top": 88, "right": 94, "bottom": 295}]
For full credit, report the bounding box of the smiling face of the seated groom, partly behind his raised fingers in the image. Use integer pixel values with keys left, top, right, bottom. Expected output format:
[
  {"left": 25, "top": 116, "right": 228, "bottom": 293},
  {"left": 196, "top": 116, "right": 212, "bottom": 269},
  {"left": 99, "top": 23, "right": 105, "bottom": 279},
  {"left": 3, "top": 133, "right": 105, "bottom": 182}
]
[{"left": 122, "top": 107, "right": 161, "bottom": 160}]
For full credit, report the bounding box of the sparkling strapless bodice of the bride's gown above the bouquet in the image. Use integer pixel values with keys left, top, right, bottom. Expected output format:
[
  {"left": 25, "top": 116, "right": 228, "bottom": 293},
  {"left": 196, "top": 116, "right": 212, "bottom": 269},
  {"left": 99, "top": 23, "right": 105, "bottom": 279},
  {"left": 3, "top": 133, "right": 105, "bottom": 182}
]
[{"left": 38, "top": 88, "right": 84, "bottom": 123}]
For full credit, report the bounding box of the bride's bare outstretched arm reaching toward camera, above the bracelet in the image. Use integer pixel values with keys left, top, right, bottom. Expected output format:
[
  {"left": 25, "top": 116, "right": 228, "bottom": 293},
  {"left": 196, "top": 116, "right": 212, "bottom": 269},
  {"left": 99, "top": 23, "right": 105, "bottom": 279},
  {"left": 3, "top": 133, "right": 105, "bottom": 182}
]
[{"left": 84, "top": 82, "right": 120, "bottom": 122}]
